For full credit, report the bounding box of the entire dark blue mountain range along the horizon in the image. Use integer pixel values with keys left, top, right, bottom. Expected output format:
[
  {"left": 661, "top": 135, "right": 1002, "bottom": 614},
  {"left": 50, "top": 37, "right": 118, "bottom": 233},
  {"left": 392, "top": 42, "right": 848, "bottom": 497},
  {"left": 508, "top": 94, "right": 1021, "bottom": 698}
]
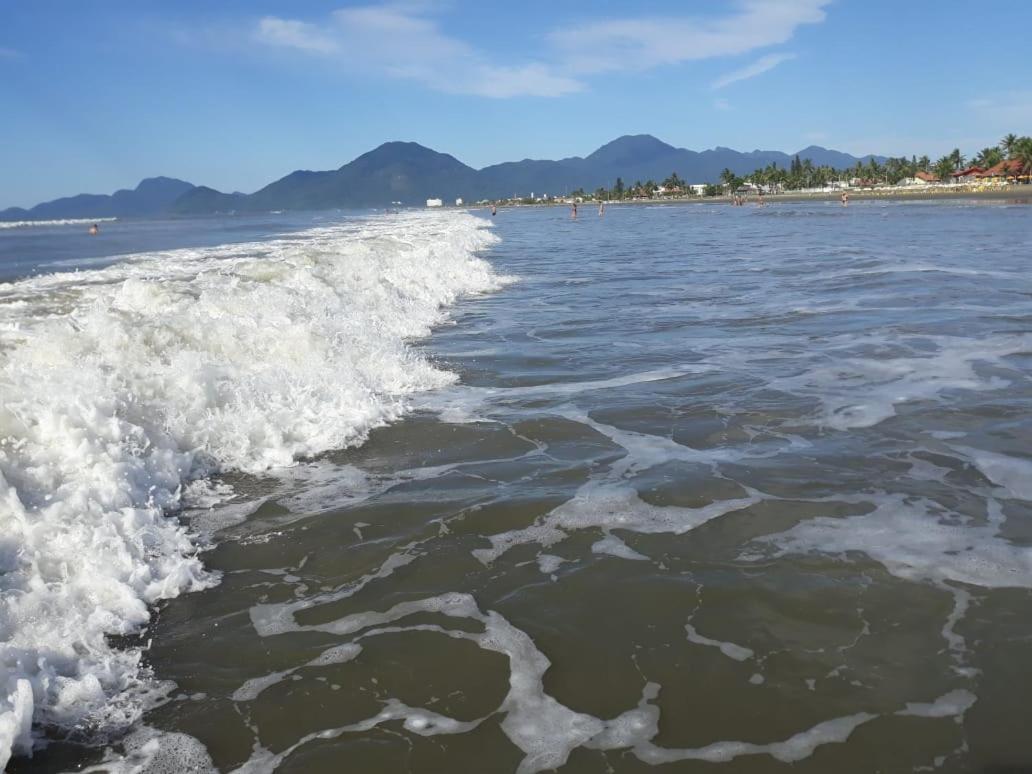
[{"left": 0, "top": 134, "right": 884, "bottom": 221}]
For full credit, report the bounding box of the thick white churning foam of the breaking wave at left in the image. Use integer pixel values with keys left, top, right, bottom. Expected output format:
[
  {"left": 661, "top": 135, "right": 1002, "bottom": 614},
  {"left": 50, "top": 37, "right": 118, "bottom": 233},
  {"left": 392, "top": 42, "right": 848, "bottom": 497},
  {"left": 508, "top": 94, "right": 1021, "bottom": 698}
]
[{"left": 0, "top": 214, "right": 503, "bottom": 768}]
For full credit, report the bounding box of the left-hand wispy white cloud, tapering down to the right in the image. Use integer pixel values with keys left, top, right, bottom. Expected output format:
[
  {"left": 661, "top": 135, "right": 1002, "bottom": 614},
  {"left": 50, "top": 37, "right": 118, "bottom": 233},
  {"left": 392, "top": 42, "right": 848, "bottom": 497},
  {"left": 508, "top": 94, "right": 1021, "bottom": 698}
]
[{"left": 254, "top": 4, "right": 583, "bottom": 98}]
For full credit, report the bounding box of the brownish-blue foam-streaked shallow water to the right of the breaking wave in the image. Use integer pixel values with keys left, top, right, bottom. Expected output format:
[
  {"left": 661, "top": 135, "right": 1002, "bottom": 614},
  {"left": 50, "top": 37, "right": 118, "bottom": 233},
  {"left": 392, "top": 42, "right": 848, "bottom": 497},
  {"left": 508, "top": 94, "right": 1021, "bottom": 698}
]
[{"left": 10, "top": 202, "right": 1032, "bottom": 772}]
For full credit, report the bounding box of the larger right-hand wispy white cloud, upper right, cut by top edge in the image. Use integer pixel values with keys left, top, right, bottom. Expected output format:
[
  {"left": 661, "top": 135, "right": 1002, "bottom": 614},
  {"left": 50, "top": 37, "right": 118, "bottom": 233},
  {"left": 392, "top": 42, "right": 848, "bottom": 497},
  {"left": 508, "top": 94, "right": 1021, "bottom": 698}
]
[{"left": 550, "top": 0, "right": 831, "bottom": 74}]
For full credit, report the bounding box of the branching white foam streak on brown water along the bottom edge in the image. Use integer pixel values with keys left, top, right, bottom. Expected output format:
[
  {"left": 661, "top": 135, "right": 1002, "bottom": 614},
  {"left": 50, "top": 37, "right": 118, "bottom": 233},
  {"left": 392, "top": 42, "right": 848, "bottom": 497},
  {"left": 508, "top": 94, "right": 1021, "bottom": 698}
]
[{"left": 236, "top": 593, "right": 879, "bottom": 774}]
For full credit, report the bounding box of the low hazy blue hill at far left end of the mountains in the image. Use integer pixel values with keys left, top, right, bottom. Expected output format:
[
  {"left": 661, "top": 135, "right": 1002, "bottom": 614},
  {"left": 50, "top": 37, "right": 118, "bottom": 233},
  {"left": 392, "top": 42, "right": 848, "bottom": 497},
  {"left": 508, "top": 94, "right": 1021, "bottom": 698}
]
[{"left": 0, "top": 178, "right": 194, "bottom": 221}]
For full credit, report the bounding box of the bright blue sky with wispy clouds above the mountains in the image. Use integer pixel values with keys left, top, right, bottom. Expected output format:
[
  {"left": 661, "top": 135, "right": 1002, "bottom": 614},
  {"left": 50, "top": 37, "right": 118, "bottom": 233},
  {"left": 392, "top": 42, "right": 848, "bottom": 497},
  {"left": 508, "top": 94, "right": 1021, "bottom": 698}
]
[{"left": 0, "top": 0, "right": 1032, "bottom": 207}]
